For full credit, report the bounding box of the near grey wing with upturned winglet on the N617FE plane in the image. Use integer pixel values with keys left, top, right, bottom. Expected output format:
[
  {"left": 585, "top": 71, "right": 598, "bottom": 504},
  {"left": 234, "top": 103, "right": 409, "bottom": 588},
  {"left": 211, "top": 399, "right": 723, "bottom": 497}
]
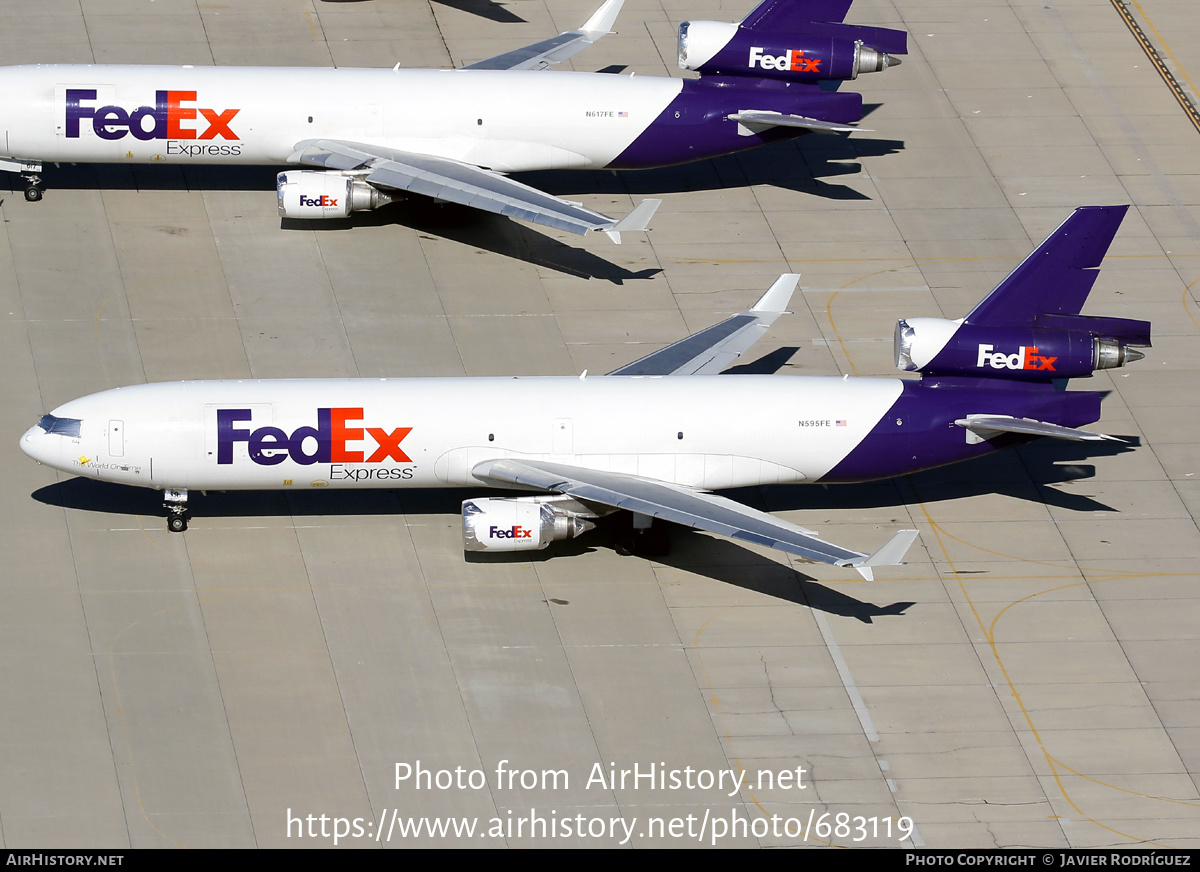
[{"left": 288, "top": 139, "right": 662, "bottom": 243}]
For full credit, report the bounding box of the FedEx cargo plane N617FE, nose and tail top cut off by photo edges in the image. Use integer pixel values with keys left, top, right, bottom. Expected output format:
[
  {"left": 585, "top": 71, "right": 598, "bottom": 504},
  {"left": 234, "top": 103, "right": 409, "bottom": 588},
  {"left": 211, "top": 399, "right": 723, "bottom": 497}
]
[{"left": 0, "top": 0, "right": 907, "bottom": 242}]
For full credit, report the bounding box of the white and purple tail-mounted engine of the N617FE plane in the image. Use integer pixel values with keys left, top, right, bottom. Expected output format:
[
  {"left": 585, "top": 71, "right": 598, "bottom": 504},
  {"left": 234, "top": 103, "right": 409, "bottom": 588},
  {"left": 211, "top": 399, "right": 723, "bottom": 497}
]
[{"left": 679, "top": 22, "right": 900, "bottom": 82}]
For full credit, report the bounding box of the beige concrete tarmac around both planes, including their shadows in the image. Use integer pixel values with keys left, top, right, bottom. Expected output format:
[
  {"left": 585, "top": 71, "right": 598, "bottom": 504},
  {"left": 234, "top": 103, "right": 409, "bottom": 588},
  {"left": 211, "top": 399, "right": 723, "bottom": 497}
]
[{"left": 0, "top": 0, "right": 1200, "bottom": 849}]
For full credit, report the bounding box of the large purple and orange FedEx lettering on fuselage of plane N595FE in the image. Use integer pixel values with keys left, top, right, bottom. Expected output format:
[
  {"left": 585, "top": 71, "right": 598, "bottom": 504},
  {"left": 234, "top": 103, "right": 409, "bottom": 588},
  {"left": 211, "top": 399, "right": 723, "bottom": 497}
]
[{"left": 217, "top": 408, "right": 413, "bottom": 467}]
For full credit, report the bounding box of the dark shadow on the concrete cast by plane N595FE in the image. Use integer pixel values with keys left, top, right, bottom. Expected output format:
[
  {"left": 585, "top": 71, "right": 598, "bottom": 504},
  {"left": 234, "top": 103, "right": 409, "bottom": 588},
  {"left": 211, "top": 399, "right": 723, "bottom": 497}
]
[{"left": 32, "top": 437, "right": 1139, "bottom": 624}]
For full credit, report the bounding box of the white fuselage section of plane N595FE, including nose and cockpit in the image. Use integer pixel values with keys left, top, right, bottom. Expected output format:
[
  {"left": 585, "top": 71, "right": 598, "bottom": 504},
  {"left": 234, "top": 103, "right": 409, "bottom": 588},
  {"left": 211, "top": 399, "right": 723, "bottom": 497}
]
[{"left": 20, "top": 375, "right": 904, "bottom": 491}]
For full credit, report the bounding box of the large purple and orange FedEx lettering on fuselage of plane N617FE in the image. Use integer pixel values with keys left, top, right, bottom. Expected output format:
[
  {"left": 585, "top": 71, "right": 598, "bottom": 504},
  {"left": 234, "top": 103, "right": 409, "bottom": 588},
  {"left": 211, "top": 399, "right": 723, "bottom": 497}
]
[{"left": 66, "top": 88, "right": 241, "bottom": 142}]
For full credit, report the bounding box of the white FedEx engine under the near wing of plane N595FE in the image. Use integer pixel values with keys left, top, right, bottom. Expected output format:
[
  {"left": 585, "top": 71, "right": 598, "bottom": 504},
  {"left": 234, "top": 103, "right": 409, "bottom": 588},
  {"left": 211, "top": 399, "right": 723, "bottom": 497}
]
[{"left": 462, "top": 497, "right": 595, "bottom": 552}]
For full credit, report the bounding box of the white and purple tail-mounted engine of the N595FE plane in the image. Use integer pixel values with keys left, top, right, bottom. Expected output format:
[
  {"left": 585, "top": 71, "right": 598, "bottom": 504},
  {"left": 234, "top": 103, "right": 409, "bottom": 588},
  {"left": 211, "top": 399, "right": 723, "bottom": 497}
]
[{"left": 894, "top": 315, "right": 1150, "bottom": 381}]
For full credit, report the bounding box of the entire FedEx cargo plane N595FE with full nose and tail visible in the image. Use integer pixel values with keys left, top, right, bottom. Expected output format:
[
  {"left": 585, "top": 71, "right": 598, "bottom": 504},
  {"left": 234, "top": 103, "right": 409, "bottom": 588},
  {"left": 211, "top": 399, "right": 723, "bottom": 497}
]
[{"left": 20, "top": 206, "right": 1150, "bottom": 578}]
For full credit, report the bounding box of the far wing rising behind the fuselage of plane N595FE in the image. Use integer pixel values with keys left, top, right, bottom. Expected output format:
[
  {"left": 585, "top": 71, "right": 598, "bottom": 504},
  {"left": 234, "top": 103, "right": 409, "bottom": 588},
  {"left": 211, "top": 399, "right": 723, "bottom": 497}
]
[{"left": 608, "top": 273, "right": 800, "bottom": 375}]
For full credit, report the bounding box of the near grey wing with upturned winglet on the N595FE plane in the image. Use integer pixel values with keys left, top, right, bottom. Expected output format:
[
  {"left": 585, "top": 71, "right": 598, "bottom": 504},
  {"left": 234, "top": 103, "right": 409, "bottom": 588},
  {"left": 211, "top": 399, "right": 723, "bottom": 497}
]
[{"left": 472, "top": 459, "right": 917, "bottom": 581}]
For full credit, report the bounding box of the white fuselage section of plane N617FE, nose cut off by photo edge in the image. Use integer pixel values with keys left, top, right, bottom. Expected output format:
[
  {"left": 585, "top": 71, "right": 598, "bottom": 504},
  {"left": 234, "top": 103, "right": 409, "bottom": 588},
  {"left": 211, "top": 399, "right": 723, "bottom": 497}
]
[{"left": 0, "top": 65, "right": 683, "bottom": 173}]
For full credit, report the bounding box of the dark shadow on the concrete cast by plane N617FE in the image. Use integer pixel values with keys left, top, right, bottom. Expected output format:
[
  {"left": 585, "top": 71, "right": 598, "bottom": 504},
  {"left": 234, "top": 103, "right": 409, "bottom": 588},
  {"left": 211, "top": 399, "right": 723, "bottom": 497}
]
[{"left": 8, "top": 133, "right": 904, "bottom": 284}]
